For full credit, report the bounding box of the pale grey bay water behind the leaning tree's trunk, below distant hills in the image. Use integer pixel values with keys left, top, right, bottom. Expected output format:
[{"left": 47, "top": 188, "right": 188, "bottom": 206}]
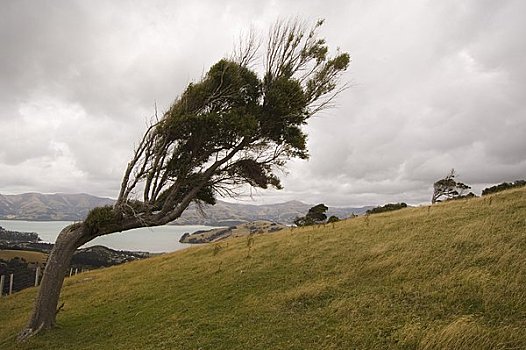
[{"left": 0, "top": 220, "right": 215, "bottom": 253}]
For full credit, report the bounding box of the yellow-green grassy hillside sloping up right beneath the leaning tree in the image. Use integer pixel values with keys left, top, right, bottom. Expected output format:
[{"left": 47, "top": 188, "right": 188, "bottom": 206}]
[{"left": 0, "top": 189, "right": 526, "bottom": 349}]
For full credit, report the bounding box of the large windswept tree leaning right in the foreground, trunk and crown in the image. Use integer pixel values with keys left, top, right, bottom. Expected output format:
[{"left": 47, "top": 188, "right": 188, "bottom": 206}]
[{"left": 18, "top": 21, "right": 349, "bottom": 340}]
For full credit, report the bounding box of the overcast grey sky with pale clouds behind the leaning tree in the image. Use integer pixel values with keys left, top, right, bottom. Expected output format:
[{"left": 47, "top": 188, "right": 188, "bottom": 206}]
[{"left": 0, "top": 0, "right": 526, "bottom": 206}]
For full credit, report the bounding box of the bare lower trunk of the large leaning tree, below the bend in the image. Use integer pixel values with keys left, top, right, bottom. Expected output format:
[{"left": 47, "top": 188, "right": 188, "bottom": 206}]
[{"left": 18, "top": 224, "right": 86, "bottom": 341}]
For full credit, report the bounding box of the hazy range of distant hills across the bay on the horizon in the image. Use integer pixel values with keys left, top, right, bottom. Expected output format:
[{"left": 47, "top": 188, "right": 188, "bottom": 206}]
[{"left": 0, "top": 193, "right": 371, "bottom": 226}]
